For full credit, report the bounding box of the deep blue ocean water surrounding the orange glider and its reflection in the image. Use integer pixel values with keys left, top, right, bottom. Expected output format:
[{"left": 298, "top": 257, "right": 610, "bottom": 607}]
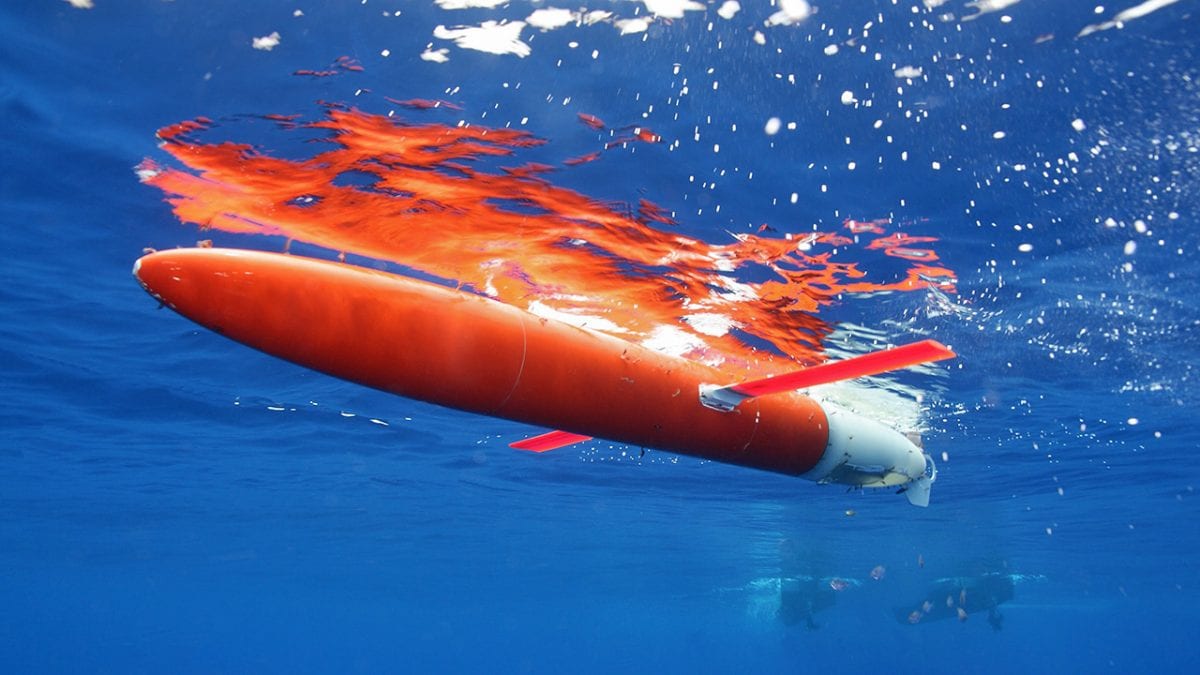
[{"left": 0, "top": 0, "right": 1200, "bottom": 673}]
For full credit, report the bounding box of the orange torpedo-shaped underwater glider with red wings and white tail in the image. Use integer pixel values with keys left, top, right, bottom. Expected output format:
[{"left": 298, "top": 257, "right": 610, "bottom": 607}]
[{"left": 133, "top": 249, "right": 954, "bottom": 506}]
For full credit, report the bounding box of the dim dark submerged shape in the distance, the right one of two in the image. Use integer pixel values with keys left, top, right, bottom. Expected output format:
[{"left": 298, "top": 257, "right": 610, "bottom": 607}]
[{"left": 895, "top": 572, "right": 1015, "bottom": 631}]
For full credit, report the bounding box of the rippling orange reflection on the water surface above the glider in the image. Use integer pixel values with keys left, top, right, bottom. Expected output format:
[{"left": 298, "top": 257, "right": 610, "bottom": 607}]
[{"left": 139, "top": 107, "right": 953, "bottom": 378}]
